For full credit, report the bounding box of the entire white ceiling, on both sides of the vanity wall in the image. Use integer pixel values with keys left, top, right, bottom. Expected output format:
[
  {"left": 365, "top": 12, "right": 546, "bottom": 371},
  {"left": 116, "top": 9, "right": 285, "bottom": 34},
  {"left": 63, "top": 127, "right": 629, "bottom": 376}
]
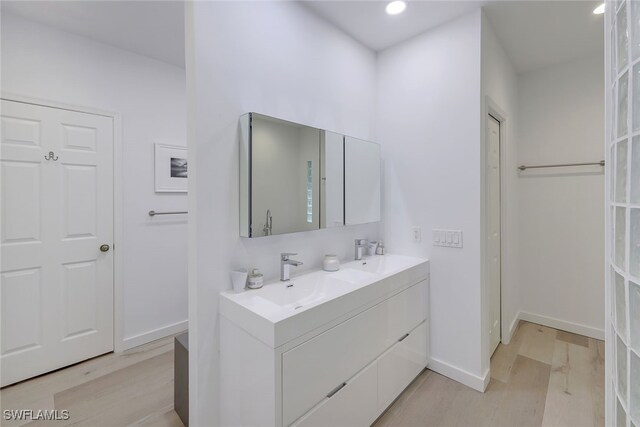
[{"left": 0, "top": 0, "right": 604, "bottom": 72}]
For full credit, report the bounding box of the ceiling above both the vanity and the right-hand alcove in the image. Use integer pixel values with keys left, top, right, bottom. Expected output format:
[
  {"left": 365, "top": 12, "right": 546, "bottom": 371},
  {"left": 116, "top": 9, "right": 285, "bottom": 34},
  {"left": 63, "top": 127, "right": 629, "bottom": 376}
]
[{"left": 303, "top": 0, "right": 604, "bottom": 72}]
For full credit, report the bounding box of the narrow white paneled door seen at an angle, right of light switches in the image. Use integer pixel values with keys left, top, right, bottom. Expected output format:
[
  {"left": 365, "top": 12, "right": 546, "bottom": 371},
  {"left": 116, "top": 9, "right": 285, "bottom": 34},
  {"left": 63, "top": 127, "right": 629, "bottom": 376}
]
[{"left": 486, "top": 116, "right": 501, "bottom": 353}]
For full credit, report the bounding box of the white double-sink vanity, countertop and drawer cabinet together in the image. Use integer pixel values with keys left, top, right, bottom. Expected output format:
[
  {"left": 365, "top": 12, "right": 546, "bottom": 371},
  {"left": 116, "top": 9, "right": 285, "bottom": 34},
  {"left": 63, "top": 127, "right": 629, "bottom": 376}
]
[{"left": 220, "top": 254, "right": 429, "bottom": 426}]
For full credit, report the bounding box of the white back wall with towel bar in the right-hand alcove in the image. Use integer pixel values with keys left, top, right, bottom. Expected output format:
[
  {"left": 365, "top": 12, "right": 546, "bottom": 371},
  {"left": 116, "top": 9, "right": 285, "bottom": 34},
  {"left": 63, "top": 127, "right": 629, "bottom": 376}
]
[{"left": 518, "top": 55, "right": 605, "bottom": 337}]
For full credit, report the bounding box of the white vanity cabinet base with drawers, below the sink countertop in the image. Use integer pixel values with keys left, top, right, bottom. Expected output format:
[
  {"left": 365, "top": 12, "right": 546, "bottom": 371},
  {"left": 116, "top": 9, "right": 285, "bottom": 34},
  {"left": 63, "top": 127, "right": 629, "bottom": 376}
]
[{"left": 220, "top": 255, "right": 429, "bottom": 427}]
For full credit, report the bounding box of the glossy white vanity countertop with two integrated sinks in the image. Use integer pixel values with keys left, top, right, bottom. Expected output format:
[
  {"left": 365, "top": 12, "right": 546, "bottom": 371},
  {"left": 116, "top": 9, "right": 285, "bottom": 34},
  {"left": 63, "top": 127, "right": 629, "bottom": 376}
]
[{"left": 220, "top": 254, "right": 429, "bottom": 348}]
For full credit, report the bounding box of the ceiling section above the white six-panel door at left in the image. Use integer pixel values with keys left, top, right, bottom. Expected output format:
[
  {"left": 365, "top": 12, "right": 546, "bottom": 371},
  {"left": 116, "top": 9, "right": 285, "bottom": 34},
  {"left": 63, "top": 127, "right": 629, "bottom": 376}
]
[{"left": 1, "top": 0, "right": 184, "bottom": 68}]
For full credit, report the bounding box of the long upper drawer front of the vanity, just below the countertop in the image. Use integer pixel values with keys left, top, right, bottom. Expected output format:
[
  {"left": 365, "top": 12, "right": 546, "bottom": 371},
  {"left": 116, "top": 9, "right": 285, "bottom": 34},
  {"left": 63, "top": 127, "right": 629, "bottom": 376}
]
[{"left": 282, "top": 282, "right": 426, "bottom": 425}]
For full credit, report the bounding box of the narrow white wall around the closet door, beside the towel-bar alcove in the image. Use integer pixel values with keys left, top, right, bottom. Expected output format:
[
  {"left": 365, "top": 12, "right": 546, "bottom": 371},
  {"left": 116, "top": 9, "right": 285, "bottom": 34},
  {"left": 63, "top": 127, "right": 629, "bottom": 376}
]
[{"left": 481, "top": 14, "right": 520, "bottom": 358}]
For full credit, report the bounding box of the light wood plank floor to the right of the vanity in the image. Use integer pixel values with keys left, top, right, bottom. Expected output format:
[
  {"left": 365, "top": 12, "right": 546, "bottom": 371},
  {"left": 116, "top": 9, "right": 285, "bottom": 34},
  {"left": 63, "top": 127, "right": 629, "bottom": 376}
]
[{"left": 375, "top": 322, "right": 604, "bottom": 427}]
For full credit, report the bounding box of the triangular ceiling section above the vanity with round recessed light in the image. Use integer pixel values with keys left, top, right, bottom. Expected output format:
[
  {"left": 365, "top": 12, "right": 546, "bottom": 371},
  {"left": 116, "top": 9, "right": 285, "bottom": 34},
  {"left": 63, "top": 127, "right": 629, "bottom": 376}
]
[{"left": 302, "top": 0, "right": 486, "bottom": 51}]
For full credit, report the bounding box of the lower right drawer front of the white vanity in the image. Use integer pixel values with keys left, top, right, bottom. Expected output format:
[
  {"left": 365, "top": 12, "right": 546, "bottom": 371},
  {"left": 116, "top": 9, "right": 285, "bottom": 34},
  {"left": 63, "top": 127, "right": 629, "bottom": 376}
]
[{"left": 378, "top": 322, "right": 427, "bottom": 412}]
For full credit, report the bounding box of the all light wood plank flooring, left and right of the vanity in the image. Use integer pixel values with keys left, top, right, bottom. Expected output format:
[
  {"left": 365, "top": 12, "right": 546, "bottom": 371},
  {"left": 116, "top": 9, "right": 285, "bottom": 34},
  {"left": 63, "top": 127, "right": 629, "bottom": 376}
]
[{"left": 0, "top": 322, "right": 604, "bottom": 427}]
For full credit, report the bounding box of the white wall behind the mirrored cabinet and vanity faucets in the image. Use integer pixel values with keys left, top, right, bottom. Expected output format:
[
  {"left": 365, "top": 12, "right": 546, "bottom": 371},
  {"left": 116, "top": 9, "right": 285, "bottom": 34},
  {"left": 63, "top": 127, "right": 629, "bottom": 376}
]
[{"left": 187, "top": 2, "right": 379, "bottom": 425}]
